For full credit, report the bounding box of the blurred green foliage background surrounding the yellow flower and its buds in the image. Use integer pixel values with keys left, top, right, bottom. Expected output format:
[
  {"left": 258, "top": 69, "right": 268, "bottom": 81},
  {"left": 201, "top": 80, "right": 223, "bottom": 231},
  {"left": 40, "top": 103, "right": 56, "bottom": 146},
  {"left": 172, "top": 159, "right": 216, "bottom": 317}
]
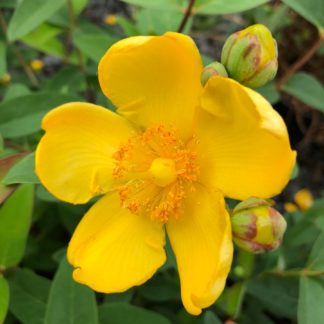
[{"left": 0, "top": 0, "right": 324, "bottom": 324}]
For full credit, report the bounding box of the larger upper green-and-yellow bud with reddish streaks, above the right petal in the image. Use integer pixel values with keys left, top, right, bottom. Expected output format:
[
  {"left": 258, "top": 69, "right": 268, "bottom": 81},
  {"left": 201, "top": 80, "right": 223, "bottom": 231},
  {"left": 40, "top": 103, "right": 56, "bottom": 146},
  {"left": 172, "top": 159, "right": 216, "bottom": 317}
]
[{"left": 221, "top": 24, "right": 278, "bottom": 88}]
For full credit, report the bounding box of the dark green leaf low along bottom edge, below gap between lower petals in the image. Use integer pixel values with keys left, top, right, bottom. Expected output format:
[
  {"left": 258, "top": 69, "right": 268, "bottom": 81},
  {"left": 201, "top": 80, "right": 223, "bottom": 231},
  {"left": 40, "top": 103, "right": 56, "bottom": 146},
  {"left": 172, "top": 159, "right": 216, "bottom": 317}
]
[{"left": 99, "top": 303, "right": 171, "bottom": 324}]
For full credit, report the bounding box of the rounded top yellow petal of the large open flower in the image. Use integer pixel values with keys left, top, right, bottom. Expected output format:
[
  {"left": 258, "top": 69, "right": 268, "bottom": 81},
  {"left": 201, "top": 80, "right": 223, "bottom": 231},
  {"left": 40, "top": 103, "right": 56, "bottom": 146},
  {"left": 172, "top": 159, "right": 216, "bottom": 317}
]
[{"left": 98, "top": 32, "right": 202, "bottom": 136}]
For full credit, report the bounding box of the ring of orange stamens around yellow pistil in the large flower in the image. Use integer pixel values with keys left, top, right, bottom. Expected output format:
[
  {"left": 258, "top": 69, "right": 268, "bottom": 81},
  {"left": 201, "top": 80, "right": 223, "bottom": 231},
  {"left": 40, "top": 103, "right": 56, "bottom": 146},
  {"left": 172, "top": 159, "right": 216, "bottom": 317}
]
[{"left": 113, "top": 126, "right": 198, "bottom": 223}]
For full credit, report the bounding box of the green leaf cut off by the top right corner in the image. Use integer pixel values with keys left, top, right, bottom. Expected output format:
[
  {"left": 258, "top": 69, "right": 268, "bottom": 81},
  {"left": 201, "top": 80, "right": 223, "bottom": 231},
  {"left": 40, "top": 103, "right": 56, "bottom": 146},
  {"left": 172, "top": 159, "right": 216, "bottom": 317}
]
[{"left": 283, "top": 0, "right": 324, "bottom": 29}]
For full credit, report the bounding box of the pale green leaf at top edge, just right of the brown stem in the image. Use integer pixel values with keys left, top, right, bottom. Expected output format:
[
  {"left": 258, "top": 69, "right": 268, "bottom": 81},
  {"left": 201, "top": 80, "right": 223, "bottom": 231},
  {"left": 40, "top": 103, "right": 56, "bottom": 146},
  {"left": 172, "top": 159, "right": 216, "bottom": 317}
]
[{"left": 193, "top": 0, "right": 269, "bottom": 15}]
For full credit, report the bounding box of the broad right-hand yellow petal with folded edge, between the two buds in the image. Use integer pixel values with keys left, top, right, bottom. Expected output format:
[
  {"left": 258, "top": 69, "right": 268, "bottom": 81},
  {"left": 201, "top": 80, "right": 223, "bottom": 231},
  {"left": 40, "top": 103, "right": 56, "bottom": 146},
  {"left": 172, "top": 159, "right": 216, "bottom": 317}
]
[{"left": 195, "top": 76, "right": 296, "bottom": 200}]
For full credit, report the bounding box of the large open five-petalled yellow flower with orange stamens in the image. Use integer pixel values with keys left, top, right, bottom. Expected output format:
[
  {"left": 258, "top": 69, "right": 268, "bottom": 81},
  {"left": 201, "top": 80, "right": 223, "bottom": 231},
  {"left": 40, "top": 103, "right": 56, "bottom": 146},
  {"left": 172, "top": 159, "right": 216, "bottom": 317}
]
[{"left": 36, "top": 33, "right": 295, "bottom": 314}]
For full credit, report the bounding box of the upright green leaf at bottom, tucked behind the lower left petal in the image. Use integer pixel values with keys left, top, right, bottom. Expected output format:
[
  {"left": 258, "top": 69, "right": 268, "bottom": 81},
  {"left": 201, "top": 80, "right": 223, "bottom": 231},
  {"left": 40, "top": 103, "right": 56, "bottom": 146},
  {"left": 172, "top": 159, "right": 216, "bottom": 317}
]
[{"left": 44, "top": 257, "right": 98, "bottom": 324}]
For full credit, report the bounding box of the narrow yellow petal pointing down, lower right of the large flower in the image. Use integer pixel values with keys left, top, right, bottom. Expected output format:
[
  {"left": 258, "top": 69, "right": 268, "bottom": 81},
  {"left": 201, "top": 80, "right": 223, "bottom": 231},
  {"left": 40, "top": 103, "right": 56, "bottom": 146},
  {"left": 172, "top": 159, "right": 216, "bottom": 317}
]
[{"left": 167, "top": 188, "right": 233, "bottom": 315}]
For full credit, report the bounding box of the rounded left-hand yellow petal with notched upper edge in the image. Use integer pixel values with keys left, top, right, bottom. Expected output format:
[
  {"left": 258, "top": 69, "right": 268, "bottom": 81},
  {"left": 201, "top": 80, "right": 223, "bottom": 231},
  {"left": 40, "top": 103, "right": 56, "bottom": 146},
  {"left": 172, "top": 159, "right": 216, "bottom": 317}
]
[{"left": 36, "top": 102, "right": 134, "bottom": 203}]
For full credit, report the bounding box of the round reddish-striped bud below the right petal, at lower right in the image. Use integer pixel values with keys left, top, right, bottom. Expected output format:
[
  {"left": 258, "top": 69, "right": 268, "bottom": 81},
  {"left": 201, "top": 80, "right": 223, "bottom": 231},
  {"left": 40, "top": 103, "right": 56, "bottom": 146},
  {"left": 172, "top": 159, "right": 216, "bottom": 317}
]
[{"left": 231, "top": 198, "right": 287, "bottom": 253}]
